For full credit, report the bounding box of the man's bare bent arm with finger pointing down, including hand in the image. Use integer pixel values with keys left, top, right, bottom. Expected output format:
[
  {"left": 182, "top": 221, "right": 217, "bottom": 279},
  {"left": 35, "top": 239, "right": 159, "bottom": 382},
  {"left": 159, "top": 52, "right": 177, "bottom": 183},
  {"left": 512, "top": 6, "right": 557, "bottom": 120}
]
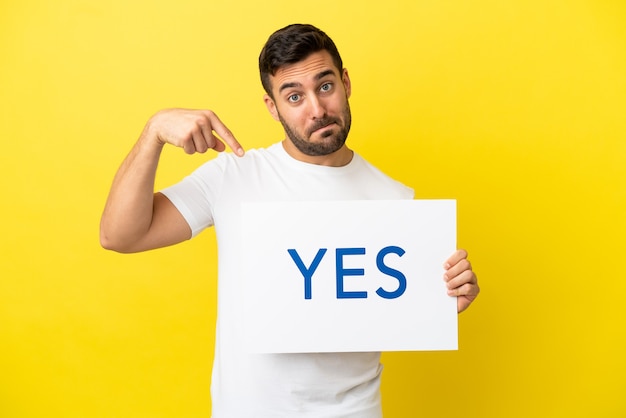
[{"left": 100, "top": 109, "right": 244, "bottom": 253}]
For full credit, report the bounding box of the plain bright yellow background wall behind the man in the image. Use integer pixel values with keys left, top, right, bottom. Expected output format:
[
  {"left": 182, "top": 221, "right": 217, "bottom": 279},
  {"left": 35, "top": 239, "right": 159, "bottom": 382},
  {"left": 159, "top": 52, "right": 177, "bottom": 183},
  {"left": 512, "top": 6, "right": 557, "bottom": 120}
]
[{"left": 0, "top": 0, "right": 626, "bottom": 418}]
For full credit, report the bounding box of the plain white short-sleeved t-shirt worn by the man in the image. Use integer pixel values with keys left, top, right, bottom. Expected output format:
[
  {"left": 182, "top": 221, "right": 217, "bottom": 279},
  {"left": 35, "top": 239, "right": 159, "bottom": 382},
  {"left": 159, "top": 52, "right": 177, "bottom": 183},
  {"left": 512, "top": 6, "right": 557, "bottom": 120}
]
[{"left": 163, "top": 143, "right": 413, "bottom": 418}]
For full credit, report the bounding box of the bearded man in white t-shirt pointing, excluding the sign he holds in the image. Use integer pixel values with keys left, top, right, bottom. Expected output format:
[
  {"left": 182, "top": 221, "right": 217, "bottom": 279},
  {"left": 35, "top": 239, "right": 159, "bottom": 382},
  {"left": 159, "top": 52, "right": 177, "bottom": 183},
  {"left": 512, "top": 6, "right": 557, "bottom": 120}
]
[{"left": 101, "top": 25, "right": 479, "bottom": 418}]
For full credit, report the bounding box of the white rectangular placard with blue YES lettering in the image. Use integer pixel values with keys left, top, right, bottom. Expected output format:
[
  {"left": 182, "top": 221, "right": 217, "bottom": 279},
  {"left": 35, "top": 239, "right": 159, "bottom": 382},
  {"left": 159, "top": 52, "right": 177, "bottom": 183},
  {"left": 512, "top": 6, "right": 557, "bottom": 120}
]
[{"left": 242, "top": 200, "right": 458, "bottom": 353}]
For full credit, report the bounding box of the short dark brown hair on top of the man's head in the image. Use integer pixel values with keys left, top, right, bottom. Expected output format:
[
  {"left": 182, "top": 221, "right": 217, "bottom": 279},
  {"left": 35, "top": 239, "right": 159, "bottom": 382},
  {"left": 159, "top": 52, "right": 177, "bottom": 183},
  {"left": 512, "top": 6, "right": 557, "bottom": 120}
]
[{"left": 259, "top": 23, "right": 343, "bottom": 98}]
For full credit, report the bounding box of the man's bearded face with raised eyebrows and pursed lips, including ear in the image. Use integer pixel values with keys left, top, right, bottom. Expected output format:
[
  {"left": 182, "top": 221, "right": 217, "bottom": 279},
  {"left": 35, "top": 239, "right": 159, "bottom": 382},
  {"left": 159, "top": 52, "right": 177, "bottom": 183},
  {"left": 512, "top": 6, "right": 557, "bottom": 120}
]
[{"left": 265, "top": 51, "right": 352, "bottom": 156}]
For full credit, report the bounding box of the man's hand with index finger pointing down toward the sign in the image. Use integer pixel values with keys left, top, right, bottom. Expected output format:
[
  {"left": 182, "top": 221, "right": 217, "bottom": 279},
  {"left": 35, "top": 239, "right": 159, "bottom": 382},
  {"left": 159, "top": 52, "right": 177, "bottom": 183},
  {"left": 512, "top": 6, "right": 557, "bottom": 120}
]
[{"left": 144, "top": 109, "right": 244, "bottom": 157}]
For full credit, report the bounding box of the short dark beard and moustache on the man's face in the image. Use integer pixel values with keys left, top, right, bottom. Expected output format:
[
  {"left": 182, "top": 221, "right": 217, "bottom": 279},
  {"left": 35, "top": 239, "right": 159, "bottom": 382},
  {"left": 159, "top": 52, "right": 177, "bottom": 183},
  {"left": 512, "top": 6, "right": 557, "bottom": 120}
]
[{"left": 278, "top": 102, "right": 352, "bottom": 157}]
